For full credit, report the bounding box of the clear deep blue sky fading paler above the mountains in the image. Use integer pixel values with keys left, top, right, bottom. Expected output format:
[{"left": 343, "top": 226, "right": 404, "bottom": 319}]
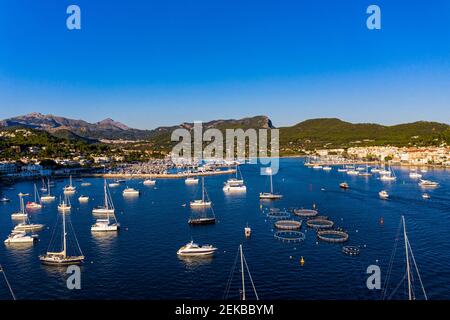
[{"left": 0, "top": 0, "right": 450, "bottom": 128}]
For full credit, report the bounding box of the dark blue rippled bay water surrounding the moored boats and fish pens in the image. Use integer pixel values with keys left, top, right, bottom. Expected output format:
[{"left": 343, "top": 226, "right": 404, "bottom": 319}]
[{"left": 0, "top": 158, "right": 450, "bottom": 299}]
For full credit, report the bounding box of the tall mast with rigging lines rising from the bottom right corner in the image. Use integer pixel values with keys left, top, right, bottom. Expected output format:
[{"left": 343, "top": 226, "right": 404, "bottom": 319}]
[{"left": 382, "top": 216, "right": 428, "bottom": 300}]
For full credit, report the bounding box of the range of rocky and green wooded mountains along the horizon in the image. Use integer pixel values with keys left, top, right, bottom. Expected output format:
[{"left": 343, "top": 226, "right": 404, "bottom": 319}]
[{"left": 0, "top": 113, "right": 450, "bottom": 153}]
